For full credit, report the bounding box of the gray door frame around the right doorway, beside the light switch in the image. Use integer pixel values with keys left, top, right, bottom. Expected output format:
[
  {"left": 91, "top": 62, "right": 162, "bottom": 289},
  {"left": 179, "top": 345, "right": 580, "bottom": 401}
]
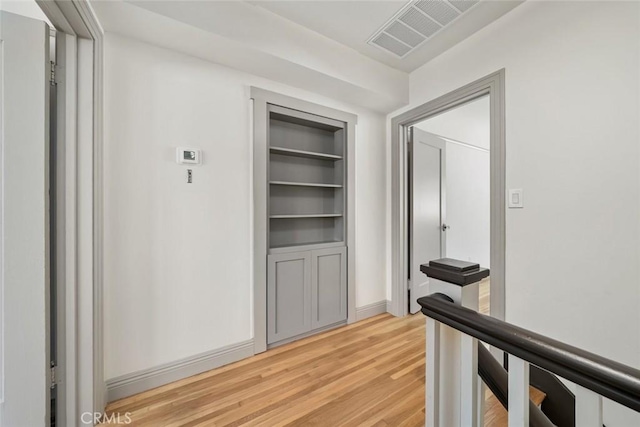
[{"left": 389, "top": 68, "right": 506, "bottom": 320}]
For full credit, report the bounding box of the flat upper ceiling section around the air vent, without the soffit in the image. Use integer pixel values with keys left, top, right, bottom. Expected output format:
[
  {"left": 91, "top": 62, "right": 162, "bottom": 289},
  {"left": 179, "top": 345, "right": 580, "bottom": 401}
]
[{"left": 249, "top": 0, "right": 522, "bottom": 72}]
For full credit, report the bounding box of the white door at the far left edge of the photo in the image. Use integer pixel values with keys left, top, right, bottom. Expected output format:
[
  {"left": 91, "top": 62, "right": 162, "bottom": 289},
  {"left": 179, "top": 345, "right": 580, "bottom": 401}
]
[{"left": 0, "top": 11, "right": 50, "bottom": 427}]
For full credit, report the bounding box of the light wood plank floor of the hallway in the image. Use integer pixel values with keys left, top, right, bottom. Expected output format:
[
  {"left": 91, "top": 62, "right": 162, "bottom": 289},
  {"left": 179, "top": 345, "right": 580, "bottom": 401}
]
[{"left": 107, "top": 302, "right": 540, "bottom": 427}]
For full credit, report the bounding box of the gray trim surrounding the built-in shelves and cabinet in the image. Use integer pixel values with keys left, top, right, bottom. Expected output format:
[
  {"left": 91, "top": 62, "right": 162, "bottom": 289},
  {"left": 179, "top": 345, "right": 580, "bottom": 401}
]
[{"left": 251, "top": 87, "right": 357, "bottom": 353}]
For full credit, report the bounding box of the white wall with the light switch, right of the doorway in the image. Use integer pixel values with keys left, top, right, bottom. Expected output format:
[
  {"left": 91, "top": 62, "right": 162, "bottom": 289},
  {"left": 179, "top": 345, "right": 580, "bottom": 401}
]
[{"left": 411, "top": 2, "right": 640, "bottom": 427}]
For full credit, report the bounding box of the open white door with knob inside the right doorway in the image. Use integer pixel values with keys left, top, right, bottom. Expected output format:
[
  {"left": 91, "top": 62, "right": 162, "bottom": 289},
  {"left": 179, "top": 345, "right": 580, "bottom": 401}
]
[{"left": 409, "top": 128, "right": 446, "bottom": 313}]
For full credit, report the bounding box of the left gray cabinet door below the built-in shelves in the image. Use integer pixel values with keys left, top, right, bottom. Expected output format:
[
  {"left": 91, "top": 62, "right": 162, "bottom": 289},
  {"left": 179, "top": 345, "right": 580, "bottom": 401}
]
[{"left": 267, "top": 251, "right": 311, "bottom": 344}]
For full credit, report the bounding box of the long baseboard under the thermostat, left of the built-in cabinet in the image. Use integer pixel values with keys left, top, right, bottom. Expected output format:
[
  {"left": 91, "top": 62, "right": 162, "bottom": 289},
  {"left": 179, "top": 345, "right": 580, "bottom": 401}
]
[{"left": 107, "top": 340, "right": 253, "bottom": 402}]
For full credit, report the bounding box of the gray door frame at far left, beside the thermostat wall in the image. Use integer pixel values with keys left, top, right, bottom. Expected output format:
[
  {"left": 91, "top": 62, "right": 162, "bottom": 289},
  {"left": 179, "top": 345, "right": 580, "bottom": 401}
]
[{"left": 36, "top": 0, "right": 106, "bottom": 426}]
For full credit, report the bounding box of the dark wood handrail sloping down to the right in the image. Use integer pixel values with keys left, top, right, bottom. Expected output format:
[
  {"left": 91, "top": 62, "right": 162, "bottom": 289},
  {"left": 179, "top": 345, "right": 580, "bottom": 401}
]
[{"left": 418, "top": 294, "right": 640, "bottom": 412}]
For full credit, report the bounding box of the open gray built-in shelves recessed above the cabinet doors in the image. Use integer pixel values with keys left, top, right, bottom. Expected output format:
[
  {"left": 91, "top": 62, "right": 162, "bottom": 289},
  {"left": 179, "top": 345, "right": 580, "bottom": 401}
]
[{"left": 268, "top": 105, "right": 345, "bottom": 249}]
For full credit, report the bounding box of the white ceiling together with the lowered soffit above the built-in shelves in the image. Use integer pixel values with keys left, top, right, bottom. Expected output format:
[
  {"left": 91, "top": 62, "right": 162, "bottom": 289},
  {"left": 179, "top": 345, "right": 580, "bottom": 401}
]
[{"left": 91, "top": 0, "right": 522, "bottom": 114}]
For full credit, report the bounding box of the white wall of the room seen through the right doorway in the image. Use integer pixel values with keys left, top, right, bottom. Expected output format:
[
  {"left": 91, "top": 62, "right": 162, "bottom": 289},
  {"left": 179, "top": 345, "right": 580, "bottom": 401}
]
[{"left": 415, "top": 97, "right": 491, "bottom": 267}]
